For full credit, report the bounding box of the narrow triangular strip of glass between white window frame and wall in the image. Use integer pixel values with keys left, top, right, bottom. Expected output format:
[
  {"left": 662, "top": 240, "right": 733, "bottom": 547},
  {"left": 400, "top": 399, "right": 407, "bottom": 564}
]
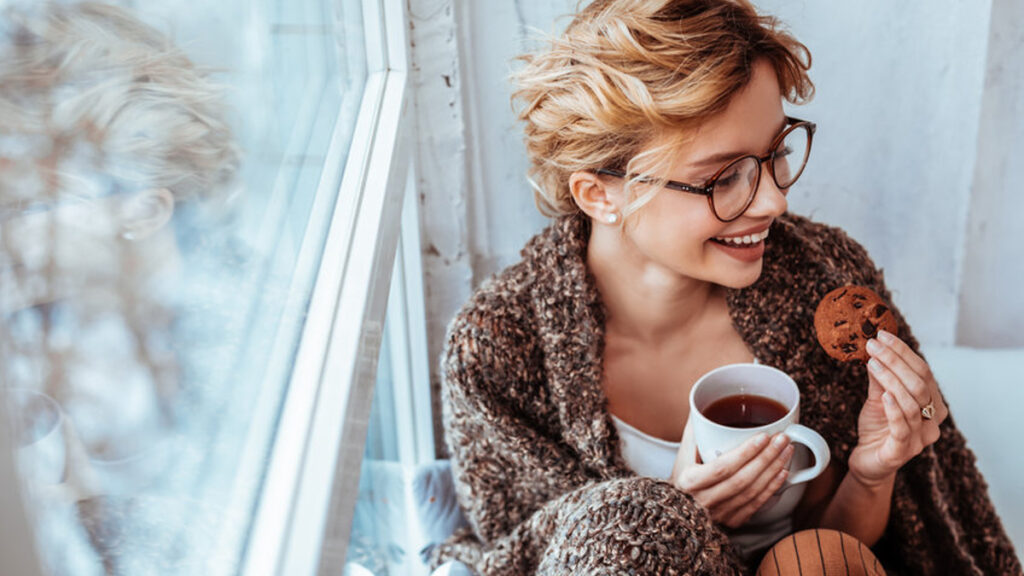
[{"left": 345, "top": 198, "right": 440, "bottom": 576}]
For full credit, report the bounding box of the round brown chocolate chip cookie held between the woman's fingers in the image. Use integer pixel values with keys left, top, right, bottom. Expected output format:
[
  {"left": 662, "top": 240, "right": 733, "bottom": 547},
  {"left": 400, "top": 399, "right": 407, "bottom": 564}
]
[{"left": 814, "top": 286, "right": 897, "bottom": 363}]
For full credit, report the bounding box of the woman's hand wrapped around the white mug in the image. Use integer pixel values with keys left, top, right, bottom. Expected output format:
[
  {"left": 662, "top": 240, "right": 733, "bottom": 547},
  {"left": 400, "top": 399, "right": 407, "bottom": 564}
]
[{"left": 670, "top": 414, "right": 795, "bottom": 528}]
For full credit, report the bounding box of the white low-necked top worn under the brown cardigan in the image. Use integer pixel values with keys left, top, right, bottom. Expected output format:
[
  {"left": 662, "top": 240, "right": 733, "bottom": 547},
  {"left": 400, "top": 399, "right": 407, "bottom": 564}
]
[{"left": 611, "top": 359, "right": 803, "bottom": 556}]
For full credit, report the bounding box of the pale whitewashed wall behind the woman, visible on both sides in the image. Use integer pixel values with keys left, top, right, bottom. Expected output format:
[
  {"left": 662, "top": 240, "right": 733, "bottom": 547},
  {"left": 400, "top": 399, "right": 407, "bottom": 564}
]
[{"left": 411, "top": 0, "right": 1024, "bottom": 438}]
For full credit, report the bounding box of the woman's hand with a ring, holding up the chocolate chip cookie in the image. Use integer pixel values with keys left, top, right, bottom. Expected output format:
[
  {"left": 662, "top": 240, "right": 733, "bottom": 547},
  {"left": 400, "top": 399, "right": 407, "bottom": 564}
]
[{"left": 849, "top": 330, "right": 949, "bottom": 486}]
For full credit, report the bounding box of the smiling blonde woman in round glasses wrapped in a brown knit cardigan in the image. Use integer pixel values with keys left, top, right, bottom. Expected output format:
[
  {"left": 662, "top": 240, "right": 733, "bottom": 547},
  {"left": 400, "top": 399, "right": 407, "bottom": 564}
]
[{"left": 430, "top": 0, "right": 1021, "bottom": 574}]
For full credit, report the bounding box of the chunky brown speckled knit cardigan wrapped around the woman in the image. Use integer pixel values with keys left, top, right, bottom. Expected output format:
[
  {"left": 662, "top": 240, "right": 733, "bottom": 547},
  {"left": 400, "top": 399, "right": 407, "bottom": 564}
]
[{"left": 434, "top": 213, "right": 1022, "bottom": 576}]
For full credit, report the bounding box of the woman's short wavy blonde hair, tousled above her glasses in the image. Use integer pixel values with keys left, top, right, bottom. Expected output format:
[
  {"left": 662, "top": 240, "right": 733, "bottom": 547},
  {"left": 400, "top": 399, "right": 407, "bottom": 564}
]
[{"left": 512, "top": 0, "right": 814, "bottom": 222}]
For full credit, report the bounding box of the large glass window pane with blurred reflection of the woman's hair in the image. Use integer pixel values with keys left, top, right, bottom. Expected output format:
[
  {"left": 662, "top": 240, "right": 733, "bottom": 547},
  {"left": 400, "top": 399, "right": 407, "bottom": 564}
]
[{"left": 0, "top": 0, "right": 366, "bottom": 576}]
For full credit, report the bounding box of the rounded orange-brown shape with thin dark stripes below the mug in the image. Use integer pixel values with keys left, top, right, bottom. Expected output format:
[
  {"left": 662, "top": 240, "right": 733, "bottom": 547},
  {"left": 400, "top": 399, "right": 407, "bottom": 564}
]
[{"left": 757, "top": 529, "right": 886, "bottom": 576}]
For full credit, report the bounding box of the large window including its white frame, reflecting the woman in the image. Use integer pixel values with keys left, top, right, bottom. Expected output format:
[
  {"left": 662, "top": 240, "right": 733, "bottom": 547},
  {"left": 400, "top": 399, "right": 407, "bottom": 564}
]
[{"left": 0, "top": 0, "right": 410, "bottom": 575}]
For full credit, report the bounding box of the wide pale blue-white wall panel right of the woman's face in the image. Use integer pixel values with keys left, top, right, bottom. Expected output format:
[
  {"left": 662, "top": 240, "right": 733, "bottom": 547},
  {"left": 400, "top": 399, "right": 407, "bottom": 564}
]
[{"left": 758, "top": 0, "right": 991, "bottom": 344}]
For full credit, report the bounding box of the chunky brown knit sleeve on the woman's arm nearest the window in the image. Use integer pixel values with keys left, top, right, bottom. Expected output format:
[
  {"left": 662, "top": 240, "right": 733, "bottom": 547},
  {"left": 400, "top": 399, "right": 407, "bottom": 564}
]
[{"left": 433, "top": 310, "right": 741, "bottom": 576}]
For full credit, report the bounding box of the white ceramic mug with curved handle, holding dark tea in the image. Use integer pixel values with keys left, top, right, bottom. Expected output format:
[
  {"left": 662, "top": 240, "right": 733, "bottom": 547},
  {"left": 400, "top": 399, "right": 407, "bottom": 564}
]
[{"left": 690, "top": 364, "right": 830, "bottom": 487}]
